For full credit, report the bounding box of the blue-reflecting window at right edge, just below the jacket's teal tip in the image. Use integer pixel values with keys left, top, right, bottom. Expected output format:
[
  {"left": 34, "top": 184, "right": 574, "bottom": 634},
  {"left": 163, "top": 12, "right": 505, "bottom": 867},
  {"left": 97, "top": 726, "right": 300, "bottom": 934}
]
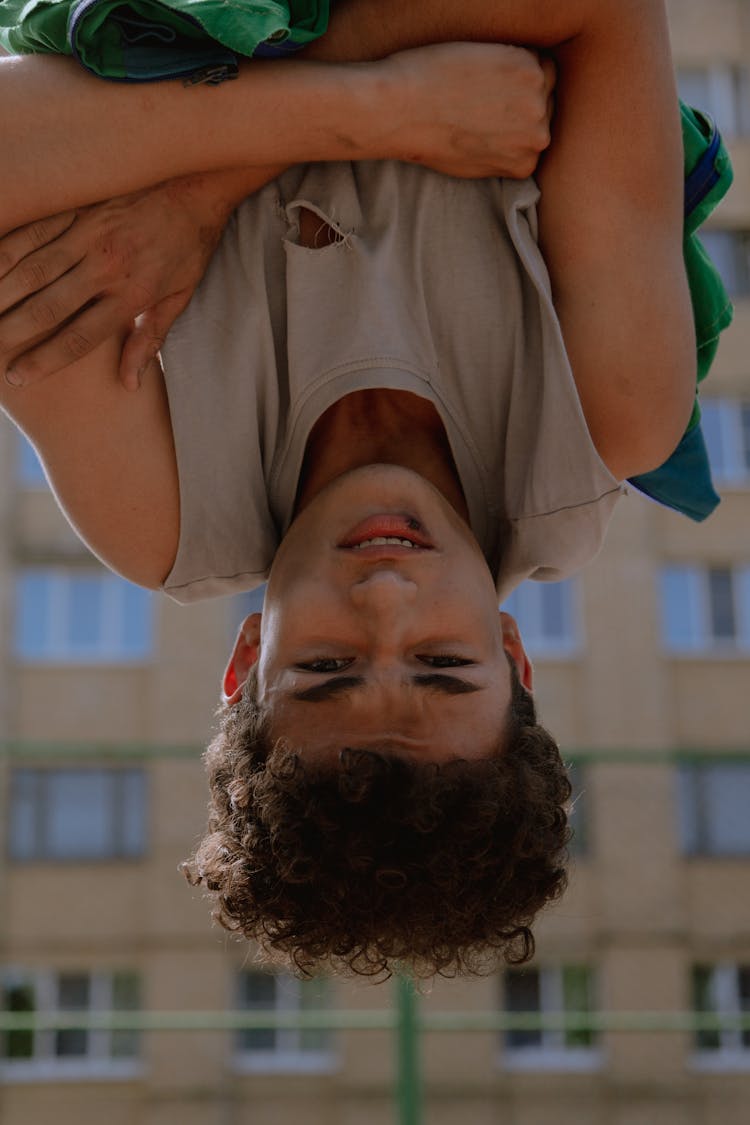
[{"left": 661, "top": 566, "right": 750, "bottom": 656}]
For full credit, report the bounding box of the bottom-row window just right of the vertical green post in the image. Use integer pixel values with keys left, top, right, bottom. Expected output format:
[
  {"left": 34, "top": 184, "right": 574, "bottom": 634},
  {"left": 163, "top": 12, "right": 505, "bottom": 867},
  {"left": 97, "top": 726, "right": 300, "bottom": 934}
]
[{"left": 503, "top": 965, "right": 602, "bottom": 1070}]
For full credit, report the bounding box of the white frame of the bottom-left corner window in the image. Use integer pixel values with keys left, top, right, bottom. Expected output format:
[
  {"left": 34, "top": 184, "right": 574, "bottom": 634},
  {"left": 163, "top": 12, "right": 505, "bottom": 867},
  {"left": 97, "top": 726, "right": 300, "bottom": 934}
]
[{"left": 0, "top": 966, "right": 145, "bottom": 1082}]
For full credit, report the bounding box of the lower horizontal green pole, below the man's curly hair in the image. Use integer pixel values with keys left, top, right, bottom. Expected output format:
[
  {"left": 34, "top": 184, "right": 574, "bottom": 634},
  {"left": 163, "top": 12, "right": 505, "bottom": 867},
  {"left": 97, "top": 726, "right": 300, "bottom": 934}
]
[{"left": 0, "top": 1010, "right": 750, "bottom": 1032}]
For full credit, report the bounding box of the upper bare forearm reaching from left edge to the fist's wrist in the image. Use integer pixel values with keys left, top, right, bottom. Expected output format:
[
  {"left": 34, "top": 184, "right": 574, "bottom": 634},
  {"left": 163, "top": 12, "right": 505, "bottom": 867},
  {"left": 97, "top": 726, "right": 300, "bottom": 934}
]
[{"left": 0, "top": 56, "right": 393, "bottom": 230}]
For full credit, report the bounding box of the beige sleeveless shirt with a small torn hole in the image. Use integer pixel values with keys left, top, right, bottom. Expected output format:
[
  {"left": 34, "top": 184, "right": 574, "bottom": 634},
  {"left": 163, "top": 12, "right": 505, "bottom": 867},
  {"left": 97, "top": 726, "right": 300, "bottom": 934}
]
[{"left": 162, "top": 162, "right": 622, "bottom": 602}]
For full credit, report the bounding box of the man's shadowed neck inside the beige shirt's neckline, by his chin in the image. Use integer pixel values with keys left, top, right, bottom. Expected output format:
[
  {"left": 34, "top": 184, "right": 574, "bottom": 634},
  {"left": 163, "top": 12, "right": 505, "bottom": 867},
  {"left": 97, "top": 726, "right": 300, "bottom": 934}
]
[{"left": 295, "top": 389, "right": 469, "bottom": 522}]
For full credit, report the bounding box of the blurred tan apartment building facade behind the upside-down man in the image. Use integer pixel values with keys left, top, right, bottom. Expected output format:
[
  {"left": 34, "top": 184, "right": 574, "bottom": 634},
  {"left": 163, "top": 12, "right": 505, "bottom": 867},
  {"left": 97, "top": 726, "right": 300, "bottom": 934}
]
[{"left": 0, "top": 0, "right": 750, "bottom": 1125}]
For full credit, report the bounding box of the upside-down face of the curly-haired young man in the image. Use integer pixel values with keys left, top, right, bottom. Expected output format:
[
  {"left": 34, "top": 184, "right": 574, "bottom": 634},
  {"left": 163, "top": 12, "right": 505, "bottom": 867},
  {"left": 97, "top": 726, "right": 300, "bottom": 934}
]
[{"left": 227, "top": 466, "right": 530, "bottom": 761}]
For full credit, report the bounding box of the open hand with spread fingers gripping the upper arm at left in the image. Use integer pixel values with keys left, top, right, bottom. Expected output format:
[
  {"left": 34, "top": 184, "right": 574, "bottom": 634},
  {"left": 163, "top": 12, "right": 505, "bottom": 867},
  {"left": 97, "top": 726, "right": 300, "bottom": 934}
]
[{"left": 0, "top": 177, "right": 231, "bottom": 389}]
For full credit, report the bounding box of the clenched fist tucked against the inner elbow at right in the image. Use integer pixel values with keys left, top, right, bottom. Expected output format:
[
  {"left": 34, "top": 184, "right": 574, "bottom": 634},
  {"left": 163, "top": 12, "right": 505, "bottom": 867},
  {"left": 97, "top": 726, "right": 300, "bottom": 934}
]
[{"left": 380, "top": 43, "right": 555, "bottom": 179}]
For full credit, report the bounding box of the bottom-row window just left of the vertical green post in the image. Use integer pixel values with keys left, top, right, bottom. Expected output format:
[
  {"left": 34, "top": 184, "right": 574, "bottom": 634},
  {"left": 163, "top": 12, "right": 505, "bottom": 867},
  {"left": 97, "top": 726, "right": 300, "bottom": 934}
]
[{"left": 236, "top": 970, "right": 335, "bottom": 1071}]
